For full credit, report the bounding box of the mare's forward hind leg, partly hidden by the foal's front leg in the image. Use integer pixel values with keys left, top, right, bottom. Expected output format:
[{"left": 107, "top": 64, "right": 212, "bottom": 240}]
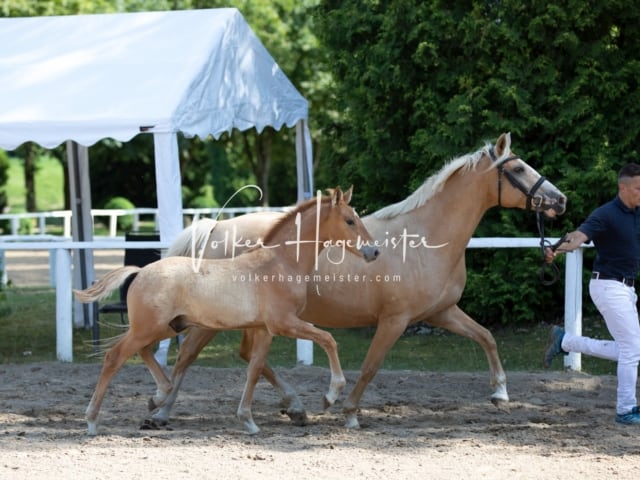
[{"left": 240, "top": 328, "right": 309, "bottom": 426}]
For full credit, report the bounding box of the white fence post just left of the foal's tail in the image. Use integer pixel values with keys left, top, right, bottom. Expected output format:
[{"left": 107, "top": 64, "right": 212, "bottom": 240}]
[{"left": 56, "top": 248, "right": 73, "bottom": 362}]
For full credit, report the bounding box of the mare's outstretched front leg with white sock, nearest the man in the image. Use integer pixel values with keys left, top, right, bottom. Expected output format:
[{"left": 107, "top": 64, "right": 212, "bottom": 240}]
[{"left": 427, "top": 305, "right": 509, "bottom": 407}]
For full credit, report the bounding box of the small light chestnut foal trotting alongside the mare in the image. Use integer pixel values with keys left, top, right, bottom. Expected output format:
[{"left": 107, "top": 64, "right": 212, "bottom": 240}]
[{"left": 75, "top": 188, "right": 378, "bottom": 435}]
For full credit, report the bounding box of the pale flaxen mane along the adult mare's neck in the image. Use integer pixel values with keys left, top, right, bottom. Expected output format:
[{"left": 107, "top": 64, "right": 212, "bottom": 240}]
[{"left": 373, "top": 142, "right": 510, "bottom": 219}]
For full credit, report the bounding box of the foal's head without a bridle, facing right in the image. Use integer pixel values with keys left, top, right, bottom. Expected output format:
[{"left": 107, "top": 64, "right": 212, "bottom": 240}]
[{"left": 321, "top": 186, "right": 380, "bottom": 262}]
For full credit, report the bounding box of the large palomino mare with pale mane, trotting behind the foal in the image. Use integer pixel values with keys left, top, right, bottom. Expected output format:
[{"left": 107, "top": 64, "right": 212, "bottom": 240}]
[{"left": 150, "top": 133, "right": 566, "bottom": 427}]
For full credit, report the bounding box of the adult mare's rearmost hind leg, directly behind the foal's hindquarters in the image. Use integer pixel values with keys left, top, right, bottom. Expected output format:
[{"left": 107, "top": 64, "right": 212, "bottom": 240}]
[{"left": 149, "top": 327, "right": 218, "bottom": 425}]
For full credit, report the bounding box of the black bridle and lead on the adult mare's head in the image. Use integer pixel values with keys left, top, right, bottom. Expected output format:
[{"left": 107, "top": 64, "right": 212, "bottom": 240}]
[{"left": 489, "top": 148, "right": 566, "bottom": 285}]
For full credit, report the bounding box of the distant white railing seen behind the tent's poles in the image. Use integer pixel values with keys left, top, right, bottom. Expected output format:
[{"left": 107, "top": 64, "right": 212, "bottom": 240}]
[{"left": 0, "top": 207, "right": 287, "bottom": 237}]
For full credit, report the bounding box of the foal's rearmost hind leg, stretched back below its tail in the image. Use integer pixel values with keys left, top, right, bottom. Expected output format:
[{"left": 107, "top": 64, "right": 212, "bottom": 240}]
[{"left": 85, "top": 331, "right": 145, "bottom": 435}]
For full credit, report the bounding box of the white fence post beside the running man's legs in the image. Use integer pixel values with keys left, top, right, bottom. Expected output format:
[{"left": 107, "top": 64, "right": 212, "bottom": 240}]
[{"left": 564, "top": 248, "right": 584, "bottom": 372}]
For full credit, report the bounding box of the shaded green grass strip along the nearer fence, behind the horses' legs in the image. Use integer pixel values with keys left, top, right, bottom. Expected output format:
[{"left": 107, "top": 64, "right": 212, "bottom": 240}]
[{"left": 0, "top": 288, "right": 615, "bottom": 374}]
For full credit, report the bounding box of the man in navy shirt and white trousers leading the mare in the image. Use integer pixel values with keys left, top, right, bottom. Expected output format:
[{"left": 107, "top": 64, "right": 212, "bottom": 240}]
[{"left": 543, "top": 163, "right": 640, "bottom": 425}]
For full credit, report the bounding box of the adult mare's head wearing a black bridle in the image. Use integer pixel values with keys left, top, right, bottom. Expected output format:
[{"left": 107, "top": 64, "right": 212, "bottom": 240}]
[{"left": 485, "top": 133, "right": 567, "bottom": 217}]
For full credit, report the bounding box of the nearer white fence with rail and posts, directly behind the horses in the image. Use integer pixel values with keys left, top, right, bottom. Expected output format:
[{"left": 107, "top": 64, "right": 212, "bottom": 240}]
[{"left": 0, "top": 237, "right": 583, "bottom": 371}]
